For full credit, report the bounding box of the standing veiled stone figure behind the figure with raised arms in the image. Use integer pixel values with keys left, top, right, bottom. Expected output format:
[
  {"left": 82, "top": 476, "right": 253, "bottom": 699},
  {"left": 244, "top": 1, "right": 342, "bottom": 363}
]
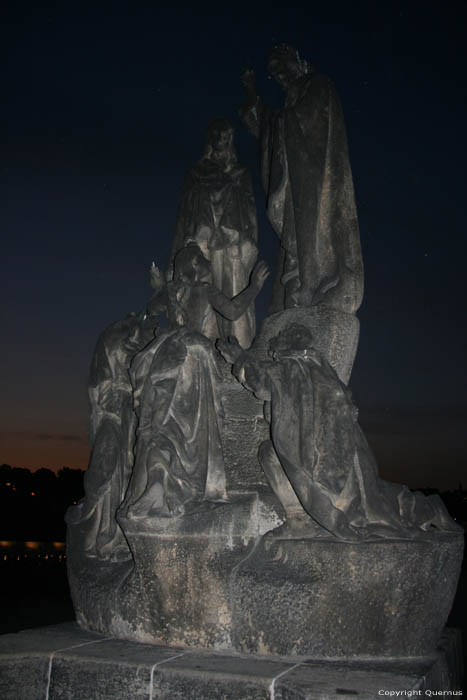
[{"left": 168, "top": 119, "right": 258, "bottom": 348}]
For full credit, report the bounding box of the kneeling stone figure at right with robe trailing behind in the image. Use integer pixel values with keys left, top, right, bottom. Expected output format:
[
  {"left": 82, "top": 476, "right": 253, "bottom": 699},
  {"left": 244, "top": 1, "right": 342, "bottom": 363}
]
[{"left": 218, "top": 324, "right": 457, "bottom": 540}]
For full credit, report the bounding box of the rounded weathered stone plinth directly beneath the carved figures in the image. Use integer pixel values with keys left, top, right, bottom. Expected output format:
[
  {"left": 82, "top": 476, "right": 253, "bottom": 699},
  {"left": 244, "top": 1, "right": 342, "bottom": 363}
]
[{"left": 68, "top": 492, "right": 463, "bottom": 658}]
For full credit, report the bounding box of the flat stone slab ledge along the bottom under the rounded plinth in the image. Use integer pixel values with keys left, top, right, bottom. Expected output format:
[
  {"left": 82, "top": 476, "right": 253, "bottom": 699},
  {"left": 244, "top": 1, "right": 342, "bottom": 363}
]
[{"left": 0, "top": 623, "right": 461, "bottom": 700}]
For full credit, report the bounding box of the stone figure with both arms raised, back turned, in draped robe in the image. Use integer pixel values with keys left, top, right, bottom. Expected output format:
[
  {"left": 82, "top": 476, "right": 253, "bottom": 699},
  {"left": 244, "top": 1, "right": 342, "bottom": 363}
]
[{"left": 122, "top": 244, "right": 268, "bottom": 518}]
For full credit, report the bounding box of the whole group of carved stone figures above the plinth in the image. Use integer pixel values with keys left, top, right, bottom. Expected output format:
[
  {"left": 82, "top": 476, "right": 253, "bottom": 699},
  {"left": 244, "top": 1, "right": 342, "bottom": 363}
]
[{"left": 67, "top": 46, "right": 457, "bottom": 561}]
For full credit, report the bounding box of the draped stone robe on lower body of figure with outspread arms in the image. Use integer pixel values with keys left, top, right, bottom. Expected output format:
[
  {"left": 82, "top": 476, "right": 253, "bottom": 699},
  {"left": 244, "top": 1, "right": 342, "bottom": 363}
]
[{"left": 123, "top": 328, "right": 226, "bottom": 518}]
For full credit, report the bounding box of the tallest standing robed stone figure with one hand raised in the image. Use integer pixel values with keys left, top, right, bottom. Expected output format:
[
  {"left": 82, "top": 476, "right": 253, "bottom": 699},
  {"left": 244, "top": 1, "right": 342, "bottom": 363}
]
[{"left": 240, "top": 46, "right": 363, "bottom": 313}]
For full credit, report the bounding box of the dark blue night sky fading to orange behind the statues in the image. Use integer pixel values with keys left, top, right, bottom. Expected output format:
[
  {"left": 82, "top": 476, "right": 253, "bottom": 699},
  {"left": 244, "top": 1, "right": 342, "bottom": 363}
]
[{"left": 0, "top": 1, "right": 467, "bottom": 489}]
